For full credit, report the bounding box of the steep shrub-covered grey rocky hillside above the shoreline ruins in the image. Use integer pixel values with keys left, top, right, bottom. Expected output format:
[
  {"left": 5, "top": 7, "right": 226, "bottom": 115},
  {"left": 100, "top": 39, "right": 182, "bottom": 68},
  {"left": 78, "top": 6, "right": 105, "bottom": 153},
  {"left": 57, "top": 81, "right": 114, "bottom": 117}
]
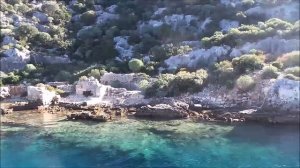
[{"left": 0, "top": 0, "right": 300, "bottom": 96}]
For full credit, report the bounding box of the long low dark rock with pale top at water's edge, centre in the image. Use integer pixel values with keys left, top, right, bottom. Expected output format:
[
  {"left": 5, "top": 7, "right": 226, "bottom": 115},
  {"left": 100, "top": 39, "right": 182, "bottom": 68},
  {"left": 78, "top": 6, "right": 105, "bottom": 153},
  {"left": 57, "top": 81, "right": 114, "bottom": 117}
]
[{"left": 135, "top": 104, "right": 188, "bottom": 119}]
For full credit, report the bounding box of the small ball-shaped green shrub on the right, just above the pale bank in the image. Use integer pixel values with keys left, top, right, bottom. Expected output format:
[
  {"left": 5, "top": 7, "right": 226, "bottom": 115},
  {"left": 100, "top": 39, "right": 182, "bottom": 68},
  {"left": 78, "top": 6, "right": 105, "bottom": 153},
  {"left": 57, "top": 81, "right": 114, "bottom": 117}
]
[{"left": 236, "top": 75, "right": 255, "bottom": 92}]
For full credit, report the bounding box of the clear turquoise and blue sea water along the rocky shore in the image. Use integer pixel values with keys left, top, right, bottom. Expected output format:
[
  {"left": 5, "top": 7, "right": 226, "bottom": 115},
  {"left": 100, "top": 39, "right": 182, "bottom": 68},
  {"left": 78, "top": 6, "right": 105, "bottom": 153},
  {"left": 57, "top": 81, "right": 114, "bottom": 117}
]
[{"left": 1, "top": 113, "right": 299, "bottom": 168}]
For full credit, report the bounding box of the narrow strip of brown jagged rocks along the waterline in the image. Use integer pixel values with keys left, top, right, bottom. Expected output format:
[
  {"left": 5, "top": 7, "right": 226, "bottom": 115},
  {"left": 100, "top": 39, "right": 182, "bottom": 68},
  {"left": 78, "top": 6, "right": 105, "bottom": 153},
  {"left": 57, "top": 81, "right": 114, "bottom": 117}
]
[{"left": 1, "top": 98, "right": 299, "bottom": 124}]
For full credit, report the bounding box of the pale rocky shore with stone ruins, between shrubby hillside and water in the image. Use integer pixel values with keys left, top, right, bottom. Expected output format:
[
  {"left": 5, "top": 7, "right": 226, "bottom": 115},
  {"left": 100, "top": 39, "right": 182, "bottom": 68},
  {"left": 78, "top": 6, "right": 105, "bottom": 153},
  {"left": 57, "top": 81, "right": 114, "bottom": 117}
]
[{"left": 1, "top": 75, "right": 300, "bottom": 124}]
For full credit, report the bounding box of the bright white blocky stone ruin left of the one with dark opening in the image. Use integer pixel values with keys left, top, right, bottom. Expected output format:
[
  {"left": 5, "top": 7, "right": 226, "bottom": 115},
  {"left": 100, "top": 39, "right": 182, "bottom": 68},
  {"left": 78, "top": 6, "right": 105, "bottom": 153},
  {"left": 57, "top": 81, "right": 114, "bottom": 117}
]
[{"left": 27, "top": 86, "right": 56, "bottom": 105}]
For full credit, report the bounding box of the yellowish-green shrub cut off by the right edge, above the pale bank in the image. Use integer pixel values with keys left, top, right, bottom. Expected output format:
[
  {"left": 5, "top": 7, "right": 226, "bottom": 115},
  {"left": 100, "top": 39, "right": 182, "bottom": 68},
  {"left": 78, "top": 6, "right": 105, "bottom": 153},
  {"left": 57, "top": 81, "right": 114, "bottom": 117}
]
[{"left": 277, "top": 51, "right": 300, "bottom": 68}]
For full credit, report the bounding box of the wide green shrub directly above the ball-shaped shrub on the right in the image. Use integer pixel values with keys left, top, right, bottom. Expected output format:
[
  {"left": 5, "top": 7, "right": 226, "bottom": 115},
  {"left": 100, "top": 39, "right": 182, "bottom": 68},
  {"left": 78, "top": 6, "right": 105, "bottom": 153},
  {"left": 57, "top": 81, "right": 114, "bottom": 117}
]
[{"left": 232, "top": 54, "right": 265, "bottom": 74}]
